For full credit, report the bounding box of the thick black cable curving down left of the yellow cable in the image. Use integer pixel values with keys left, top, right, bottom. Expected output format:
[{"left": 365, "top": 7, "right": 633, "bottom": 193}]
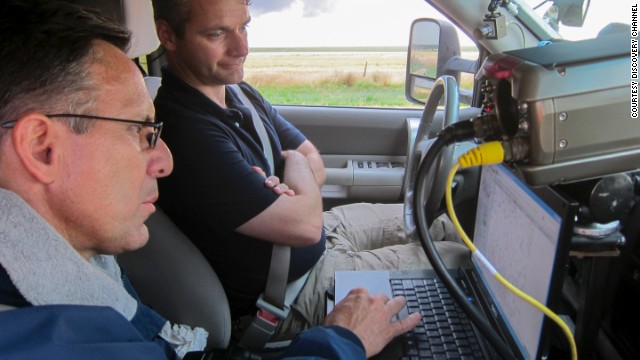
[{"left": 413, "top": 126, "right": 515, "bottom": 359}]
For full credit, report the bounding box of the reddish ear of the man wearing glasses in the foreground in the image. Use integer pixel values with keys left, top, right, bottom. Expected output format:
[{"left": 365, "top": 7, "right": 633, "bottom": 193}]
[{"left": 11, "top": 113, "right": 58, "bottom": 184}]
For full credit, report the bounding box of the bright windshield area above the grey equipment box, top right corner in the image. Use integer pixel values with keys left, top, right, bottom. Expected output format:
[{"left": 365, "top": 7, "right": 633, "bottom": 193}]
[{"left": 524, "top": 0, "right": 634, "bottom": 40}]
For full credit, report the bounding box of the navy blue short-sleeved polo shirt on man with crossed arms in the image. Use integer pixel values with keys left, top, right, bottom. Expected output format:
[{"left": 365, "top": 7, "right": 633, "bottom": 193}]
[{"left": 155, "top": 69, "right": 325, "bottom": 316}]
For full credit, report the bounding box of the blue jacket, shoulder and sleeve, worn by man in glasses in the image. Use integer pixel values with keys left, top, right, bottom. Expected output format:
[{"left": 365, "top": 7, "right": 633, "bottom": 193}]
[{"left": 0, "top": 305, "right": 365, "bottom": 360}]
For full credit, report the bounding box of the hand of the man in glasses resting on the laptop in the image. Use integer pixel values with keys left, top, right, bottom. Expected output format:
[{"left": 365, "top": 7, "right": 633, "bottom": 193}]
[{"left": 324, "top": 288, "right": 422, "bottom": 358}]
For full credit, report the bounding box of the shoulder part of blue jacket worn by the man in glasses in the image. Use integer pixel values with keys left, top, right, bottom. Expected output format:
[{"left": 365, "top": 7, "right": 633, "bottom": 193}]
[{"left": 0, "top": 305, "right": 177, "bottom": 360}]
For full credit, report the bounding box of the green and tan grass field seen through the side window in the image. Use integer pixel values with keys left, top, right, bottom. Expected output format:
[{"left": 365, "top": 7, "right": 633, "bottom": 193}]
[{"left": 245, "top": 48, "right": 470, "bottom": 108}]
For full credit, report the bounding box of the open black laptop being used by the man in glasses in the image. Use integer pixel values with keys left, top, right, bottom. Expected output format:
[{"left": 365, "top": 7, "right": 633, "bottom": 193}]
[{"left": 335, "top": 164, "right": 577, "bottom": 359}]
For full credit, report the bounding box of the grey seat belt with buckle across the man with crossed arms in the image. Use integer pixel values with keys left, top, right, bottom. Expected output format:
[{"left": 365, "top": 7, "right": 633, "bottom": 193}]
[{"left": 227, "top": 84, "right": 308, "bottom": 349}]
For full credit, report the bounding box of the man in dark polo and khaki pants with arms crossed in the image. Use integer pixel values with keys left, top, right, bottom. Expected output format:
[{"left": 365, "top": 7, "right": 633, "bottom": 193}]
[{"left": 153, "top": 0, "right": 468, "bottom": 338}]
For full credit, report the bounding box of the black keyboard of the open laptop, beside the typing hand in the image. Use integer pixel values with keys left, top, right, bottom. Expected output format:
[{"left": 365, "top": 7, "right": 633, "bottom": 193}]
[{"left": 391, "top": 279, "right": 483, "bottom": 360}]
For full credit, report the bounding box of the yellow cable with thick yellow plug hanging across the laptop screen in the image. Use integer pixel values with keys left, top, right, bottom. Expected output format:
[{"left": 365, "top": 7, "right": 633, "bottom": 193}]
[{"left": 445, "top": 141, "right": 578, "bottom": 360}]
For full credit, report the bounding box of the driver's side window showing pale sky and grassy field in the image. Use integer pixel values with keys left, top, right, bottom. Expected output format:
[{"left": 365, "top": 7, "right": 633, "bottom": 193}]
[{"left": 245, "top": 0, "right": 477, "bottom": 108}]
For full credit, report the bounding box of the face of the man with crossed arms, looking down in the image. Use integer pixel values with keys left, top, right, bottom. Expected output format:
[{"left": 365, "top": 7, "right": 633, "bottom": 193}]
[{"left": 168, "top": 0, "right": 250, "bottom": 86}]
